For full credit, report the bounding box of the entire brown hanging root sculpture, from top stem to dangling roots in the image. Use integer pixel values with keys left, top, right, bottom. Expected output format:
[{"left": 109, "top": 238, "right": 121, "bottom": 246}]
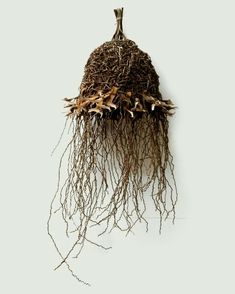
[{"left": 48, "top": 9, "right": 177, "bottom": 281}]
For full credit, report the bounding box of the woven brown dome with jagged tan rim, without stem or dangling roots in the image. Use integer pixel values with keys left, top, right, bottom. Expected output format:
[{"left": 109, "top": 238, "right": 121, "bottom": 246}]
[{"left": 65, "top": 40, "right": 174, "bottom": 118}]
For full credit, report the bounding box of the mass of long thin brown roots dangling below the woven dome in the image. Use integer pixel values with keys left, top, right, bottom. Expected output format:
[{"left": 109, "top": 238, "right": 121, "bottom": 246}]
[{"left": 48, "top": 108, "right": 177, "bottom": 284}]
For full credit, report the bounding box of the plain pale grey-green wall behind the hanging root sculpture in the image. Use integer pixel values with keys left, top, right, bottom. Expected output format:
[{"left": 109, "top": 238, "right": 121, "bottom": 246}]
[{"left": 0, "top": 0, "right": 235, "bottom": 294}]
